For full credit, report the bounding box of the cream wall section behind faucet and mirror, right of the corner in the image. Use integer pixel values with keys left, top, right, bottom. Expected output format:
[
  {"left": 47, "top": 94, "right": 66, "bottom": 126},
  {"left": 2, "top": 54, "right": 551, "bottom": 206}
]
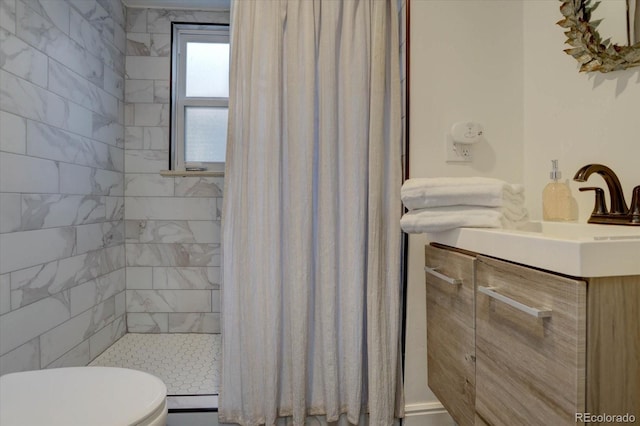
[{"left": 523, "top": 0, "right": 640, "bottom": 221}]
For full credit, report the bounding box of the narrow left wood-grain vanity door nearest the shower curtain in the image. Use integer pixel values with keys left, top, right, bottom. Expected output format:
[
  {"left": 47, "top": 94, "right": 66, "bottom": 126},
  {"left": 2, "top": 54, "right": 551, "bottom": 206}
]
[{"left": 425, "top": 246, "right": 475, "bottom": 426}]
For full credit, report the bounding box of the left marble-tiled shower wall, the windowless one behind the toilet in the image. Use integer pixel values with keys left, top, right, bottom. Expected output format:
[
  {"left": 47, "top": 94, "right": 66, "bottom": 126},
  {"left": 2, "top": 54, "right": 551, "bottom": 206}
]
[{"left": 0, "top": 0, "right": 126, "bottom": 374}]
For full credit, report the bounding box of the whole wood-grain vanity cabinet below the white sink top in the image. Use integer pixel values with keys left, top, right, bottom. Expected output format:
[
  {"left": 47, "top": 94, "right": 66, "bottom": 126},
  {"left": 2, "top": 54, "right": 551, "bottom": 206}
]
[{"left": 426, "top": 246, "right": 640, "bottom": 426}]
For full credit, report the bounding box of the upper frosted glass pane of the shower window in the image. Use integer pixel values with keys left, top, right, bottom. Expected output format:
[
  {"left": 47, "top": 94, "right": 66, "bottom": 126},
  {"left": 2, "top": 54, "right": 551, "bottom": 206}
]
[{"left": 186, "top": 43, "right": 229, "bottom": 98}]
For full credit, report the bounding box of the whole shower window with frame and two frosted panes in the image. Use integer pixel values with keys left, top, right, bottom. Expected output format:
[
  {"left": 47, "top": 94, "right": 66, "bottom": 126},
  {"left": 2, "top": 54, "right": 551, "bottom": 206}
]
[{"left": 170, "top": 23, "right": 229, "bottom": 171}]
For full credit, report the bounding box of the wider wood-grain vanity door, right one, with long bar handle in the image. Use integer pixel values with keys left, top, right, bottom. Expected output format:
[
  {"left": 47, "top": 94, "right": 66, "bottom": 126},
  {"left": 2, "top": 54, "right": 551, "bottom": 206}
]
[{"left": 476, "top": 257, "right": 586, "bottom": 426}]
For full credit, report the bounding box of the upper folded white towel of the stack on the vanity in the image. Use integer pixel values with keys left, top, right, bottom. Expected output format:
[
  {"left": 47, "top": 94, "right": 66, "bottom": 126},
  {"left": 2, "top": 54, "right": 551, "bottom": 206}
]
[{"left": 401, "top": 177, "right": 524, "bottom": 210}]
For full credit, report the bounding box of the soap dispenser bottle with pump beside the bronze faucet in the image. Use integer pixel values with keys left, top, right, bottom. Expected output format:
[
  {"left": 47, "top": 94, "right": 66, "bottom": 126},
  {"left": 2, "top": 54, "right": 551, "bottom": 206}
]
[{"left": 542, "top": 160, "right": 578, "bottom": 222}]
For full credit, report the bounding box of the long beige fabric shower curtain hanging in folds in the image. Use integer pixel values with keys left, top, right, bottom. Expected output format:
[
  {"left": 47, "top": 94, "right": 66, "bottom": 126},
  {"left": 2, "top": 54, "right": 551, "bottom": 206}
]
[{"left": 219, "top": 0, "right": 402, "bottom": 425}]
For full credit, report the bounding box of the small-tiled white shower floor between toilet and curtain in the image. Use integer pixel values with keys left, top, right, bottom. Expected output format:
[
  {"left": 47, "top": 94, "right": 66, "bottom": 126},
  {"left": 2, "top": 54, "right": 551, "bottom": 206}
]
[{"left": 90, "top": 333, "right": 221, "bottom": 409}]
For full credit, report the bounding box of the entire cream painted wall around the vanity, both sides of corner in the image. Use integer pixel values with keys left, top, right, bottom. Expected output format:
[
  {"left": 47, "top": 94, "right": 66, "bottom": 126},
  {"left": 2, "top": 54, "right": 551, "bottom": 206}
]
[{"left": 405, "top": 0, "right": 640, "bottom": 426}]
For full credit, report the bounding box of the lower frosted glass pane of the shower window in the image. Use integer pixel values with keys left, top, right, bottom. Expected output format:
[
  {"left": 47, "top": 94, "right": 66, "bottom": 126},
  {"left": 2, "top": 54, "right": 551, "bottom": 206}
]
[{"left": 185, "top": 107, "right": 229, "bottom": 162}]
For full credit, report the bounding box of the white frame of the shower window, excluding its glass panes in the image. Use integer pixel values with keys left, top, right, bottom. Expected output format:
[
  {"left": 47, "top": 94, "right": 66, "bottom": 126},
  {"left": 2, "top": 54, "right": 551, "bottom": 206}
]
[{"left": 169, "top": 22, "right": 229, "bottom": 172}]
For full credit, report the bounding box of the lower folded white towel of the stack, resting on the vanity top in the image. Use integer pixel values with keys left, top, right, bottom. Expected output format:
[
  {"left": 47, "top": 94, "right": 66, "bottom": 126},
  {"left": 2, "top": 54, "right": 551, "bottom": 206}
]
[{"left": 400, "top": 206, "right": 528, "bottom": 234}]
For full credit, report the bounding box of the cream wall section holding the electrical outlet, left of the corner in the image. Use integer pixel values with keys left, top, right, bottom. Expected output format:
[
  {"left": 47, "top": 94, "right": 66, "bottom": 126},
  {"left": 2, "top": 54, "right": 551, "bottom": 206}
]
[{"left": 405, "top": 0, "right": 523, "bottom": 426}]
